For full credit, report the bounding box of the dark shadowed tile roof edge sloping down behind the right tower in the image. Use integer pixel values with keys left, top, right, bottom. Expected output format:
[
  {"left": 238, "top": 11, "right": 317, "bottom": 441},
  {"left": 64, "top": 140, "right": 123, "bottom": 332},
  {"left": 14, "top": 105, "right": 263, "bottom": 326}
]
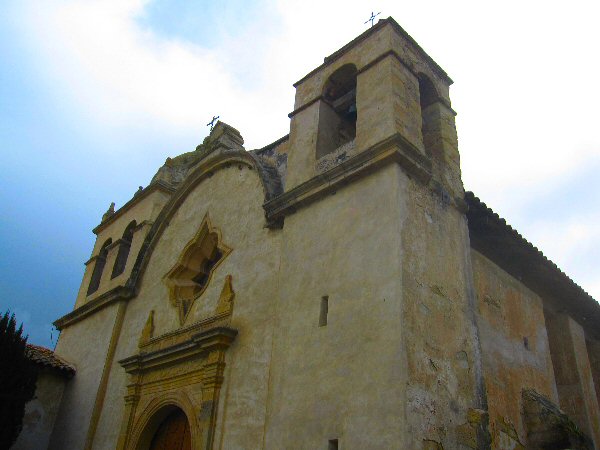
[{"left": 465, "top": 192, "right": 600, "bottom": 338}]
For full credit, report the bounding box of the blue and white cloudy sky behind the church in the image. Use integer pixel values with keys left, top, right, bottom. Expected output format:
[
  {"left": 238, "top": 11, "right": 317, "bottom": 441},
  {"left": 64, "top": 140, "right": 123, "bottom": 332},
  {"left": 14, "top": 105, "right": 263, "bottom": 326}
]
[{"left": 0, "top": 0, "right": 600, "bottom": 348}]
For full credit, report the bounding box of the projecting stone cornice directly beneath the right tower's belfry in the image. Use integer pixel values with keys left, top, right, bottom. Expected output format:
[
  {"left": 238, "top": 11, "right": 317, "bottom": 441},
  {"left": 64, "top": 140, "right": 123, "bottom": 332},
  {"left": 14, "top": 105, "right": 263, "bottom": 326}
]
[{"left": 263, "top": 134, "right": 431, "bottom": 226}]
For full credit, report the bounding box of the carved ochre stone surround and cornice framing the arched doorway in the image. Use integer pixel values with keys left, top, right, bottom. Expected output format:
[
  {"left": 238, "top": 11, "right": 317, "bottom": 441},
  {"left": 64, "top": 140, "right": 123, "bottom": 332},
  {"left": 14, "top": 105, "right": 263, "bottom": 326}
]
[{"left": 117, "top": 324, "right": 237, "bottom": 450}]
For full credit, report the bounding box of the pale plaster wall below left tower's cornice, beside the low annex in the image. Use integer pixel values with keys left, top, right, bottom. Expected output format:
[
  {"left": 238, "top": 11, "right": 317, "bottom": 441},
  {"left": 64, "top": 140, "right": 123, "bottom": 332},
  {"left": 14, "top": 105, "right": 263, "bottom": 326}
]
[{"left": 49, "top": 304, "right": 118, "bottom": 450}]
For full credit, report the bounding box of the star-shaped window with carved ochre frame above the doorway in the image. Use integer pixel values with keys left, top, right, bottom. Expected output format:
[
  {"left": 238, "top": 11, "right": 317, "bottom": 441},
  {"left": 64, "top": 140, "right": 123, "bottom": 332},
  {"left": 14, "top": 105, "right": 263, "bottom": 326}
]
[{"left": 164, "top": 214, "right": 231, "bottom": 325}]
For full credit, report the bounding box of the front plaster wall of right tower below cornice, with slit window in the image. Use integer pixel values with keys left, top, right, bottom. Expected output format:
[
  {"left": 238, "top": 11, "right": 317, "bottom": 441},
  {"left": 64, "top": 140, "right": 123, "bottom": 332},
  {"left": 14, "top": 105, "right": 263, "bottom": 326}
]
[{"left": 266, "top": 165, "right": 409, "bottom": 450}]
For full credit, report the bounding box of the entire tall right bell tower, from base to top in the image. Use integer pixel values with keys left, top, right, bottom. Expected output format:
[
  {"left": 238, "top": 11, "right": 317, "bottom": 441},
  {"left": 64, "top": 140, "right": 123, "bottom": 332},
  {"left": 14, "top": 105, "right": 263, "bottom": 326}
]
[{"left": 264, "top": 18, "right": 490, "bottom": 449}]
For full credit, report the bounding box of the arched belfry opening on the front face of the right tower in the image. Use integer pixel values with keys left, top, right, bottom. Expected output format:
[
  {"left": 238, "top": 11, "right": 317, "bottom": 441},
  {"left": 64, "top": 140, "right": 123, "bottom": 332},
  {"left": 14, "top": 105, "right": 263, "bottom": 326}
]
[{"left": 317, "top": 64, "right": 357, "bottom": 159}]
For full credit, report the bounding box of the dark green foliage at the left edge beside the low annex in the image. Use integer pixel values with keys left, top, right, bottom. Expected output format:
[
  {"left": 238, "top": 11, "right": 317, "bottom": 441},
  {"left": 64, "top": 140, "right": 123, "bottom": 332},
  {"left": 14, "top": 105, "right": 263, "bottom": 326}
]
[{"left": 0, "top": 312, "right": 37, "bottom": 450}]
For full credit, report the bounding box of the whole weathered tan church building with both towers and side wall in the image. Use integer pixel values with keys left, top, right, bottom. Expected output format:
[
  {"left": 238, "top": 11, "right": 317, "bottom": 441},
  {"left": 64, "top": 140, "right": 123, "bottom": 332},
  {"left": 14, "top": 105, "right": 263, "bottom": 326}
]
[{"left": 44, "top": 18, "right": 600, "bottom": 450}]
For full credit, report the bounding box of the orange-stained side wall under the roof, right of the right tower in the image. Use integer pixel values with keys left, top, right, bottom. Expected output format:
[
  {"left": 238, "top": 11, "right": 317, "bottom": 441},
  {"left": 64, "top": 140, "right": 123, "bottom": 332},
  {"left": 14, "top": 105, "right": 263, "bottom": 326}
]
[{"left": 471, "top": 250, "right": 558, "bottom": 449}]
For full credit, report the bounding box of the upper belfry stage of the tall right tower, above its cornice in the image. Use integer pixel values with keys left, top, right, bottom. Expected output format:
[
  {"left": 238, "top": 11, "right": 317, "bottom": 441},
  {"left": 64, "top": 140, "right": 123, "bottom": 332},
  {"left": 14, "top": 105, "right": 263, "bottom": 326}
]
[{"left": 286, "top": 18, "right": 463, "bottom": 198}]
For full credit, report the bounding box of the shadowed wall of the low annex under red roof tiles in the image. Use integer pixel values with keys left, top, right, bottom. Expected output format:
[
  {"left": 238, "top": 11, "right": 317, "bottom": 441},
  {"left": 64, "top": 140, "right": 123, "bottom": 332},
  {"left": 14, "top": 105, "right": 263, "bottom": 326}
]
[{"left": 11, "top": 369, "right": 67, "bottom": 450}]
